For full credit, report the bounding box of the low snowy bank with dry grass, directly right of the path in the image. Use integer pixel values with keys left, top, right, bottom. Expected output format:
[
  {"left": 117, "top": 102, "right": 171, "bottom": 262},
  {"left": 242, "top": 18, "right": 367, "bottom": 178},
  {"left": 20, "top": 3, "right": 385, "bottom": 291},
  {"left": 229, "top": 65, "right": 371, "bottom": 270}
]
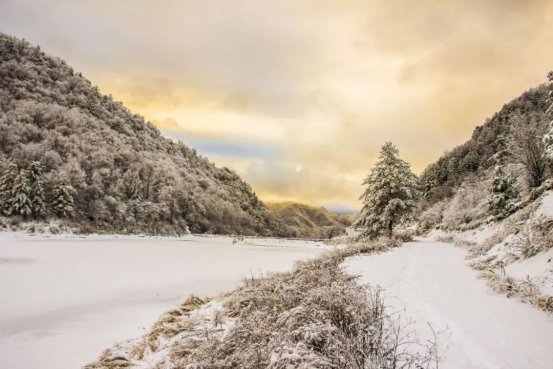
[{"left": 428, "top": 191, "right": 553, "bottom": 311}]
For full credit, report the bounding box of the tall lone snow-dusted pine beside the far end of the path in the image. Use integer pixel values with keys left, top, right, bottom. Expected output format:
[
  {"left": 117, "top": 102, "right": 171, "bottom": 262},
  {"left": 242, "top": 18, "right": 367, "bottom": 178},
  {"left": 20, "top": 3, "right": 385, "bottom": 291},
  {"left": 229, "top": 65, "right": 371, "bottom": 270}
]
[{"left": 356, "top": 142, "right": 419, "bottom": 237}]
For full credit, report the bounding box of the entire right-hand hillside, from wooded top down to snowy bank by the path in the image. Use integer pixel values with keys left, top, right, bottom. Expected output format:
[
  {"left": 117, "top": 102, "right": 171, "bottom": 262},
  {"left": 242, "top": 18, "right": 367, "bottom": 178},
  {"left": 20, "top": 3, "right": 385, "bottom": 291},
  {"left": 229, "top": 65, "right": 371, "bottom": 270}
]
[{"left": 417, "top": 76, "right": 553, "bottom": 312}]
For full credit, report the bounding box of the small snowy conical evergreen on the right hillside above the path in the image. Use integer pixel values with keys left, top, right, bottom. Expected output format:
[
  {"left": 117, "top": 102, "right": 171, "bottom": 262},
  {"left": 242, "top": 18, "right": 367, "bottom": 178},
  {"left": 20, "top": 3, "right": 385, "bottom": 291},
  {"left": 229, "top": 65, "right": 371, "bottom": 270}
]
[{"left": 488, "top": 165, "right": 518, "bottom": 217}]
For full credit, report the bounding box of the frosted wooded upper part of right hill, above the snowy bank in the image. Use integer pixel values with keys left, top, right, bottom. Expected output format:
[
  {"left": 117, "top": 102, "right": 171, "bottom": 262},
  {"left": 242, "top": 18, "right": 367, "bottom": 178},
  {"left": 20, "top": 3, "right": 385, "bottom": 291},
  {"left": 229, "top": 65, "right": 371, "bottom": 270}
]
[{"left": 419, "top": 76, "right": 553, "bottom": 230}]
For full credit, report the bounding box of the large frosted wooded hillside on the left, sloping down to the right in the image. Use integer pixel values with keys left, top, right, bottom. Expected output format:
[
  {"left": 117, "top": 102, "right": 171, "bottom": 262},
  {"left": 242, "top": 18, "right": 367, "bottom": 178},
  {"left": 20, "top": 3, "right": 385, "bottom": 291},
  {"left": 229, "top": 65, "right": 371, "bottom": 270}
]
[{"left": 0, "top": 34, "right": 288, "bottom": 235}]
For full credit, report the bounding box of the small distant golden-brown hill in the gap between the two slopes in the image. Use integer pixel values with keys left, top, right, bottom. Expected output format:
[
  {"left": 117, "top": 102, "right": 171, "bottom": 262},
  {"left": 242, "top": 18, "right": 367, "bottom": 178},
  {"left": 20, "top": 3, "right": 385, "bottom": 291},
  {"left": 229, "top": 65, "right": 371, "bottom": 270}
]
[{"left": 267, "top": 202, "right": 352, "bottom": 238}]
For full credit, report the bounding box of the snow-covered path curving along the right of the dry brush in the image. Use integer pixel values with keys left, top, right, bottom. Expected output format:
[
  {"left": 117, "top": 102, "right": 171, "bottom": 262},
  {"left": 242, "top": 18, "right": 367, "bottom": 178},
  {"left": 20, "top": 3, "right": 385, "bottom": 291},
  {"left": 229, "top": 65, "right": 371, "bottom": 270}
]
[{"left": 345, "top": 241, "right": 553, "bottom": 369}]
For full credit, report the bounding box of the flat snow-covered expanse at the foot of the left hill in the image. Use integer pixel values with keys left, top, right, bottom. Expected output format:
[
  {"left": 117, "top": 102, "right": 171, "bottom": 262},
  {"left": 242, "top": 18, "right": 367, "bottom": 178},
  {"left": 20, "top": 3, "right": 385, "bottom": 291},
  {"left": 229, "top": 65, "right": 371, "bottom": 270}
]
[{"left": 0, "top": 233, "right": 324, "bottom": 369}]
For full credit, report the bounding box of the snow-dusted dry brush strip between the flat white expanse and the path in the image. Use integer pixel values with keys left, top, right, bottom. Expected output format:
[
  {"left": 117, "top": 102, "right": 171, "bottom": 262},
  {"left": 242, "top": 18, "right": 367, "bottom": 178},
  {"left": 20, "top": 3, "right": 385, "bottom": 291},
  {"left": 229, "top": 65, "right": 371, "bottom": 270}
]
[{"left": 89, "top": 240, "right": 438, "bottom": 369}]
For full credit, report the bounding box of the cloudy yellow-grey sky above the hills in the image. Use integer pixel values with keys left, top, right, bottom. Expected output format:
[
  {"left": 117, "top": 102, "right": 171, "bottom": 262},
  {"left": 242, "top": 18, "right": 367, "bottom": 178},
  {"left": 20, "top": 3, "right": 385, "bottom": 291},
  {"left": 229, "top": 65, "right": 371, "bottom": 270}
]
[{"left": 0, "top": 0, "right": 553, "bottom": 211}]
